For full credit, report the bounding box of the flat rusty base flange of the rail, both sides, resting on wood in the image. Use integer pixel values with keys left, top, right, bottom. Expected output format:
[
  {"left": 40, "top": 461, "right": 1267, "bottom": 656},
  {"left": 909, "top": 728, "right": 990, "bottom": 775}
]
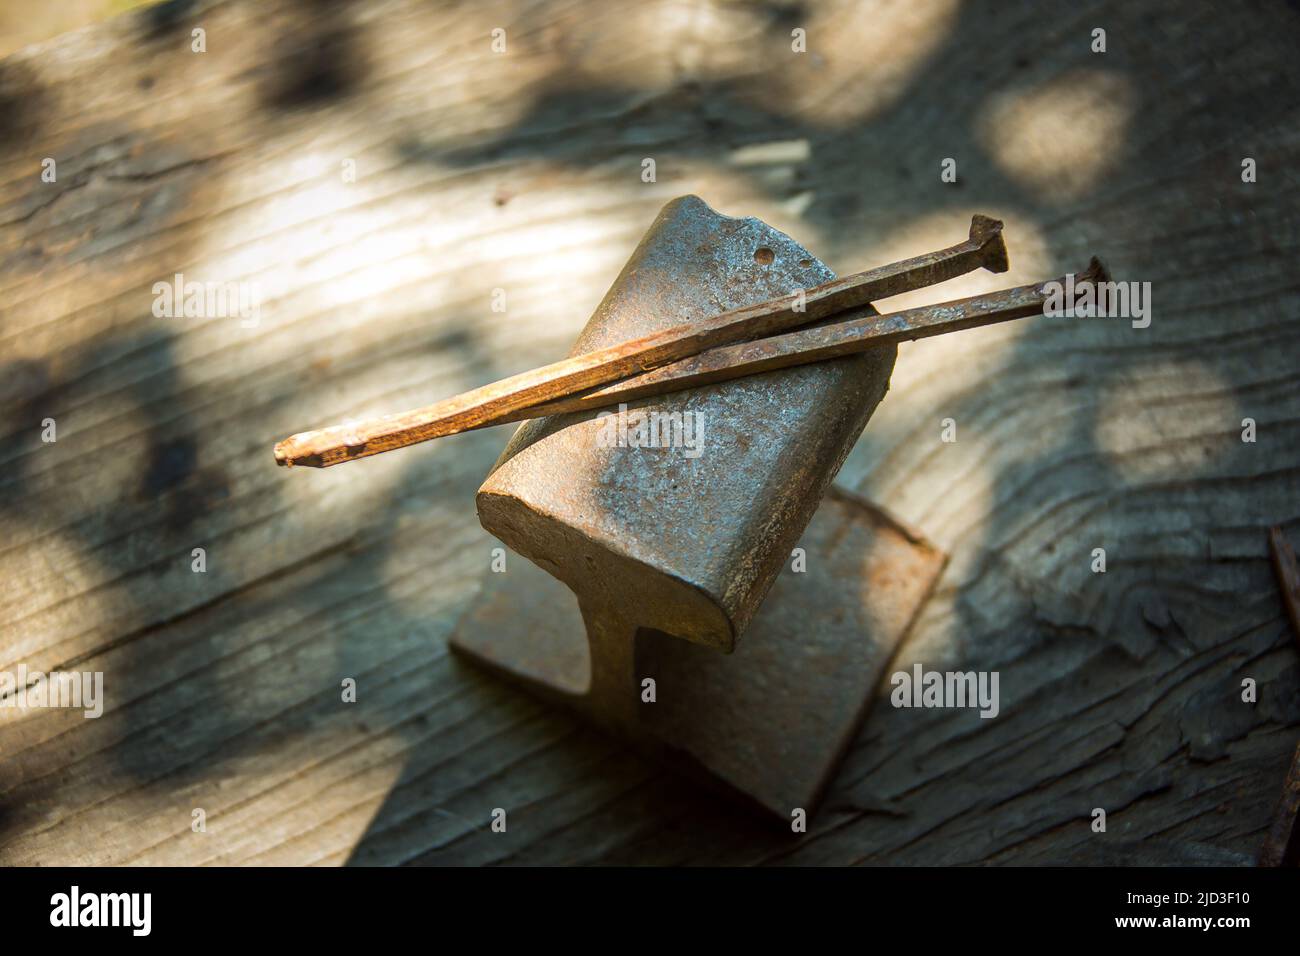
[{"left": 451, "top": 489, "right": 945, "bottom": 821}]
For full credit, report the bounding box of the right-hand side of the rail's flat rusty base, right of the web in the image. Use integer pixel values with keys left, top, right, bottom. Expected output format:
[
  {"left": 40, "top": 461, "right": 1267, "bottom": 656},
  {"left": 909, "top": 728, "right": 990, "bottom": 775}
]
[{"left": 638, "top": 489, "right": 946, "bottom": 821}]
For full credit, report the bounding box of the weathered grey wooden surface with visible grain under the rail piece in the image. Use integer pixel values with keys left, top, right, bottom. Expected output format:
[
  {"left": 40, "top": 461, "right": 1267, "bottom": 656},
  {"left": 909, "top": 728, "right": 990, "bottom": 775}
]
[{"left": 0, "top": 0, "right": 1300, "bottom": 864}]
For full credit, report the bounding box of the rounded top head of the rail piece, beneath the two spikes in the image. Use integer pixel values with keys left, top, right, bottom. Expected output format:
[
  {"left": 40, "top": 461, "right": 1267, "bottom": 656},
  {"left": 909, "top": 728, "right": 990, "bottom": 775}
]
[{"left": 477, "top": 196, "right": 896, "bottom": 650}]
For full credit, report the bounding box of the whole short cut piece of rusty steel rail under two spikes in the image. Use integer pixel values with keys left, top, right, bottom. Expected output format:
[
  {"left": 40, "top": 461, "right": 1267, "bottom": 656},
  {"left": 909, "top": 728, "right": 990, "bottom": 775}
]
[{"left": 452, "top": 196, "right": 944, "bottom": 819}]
